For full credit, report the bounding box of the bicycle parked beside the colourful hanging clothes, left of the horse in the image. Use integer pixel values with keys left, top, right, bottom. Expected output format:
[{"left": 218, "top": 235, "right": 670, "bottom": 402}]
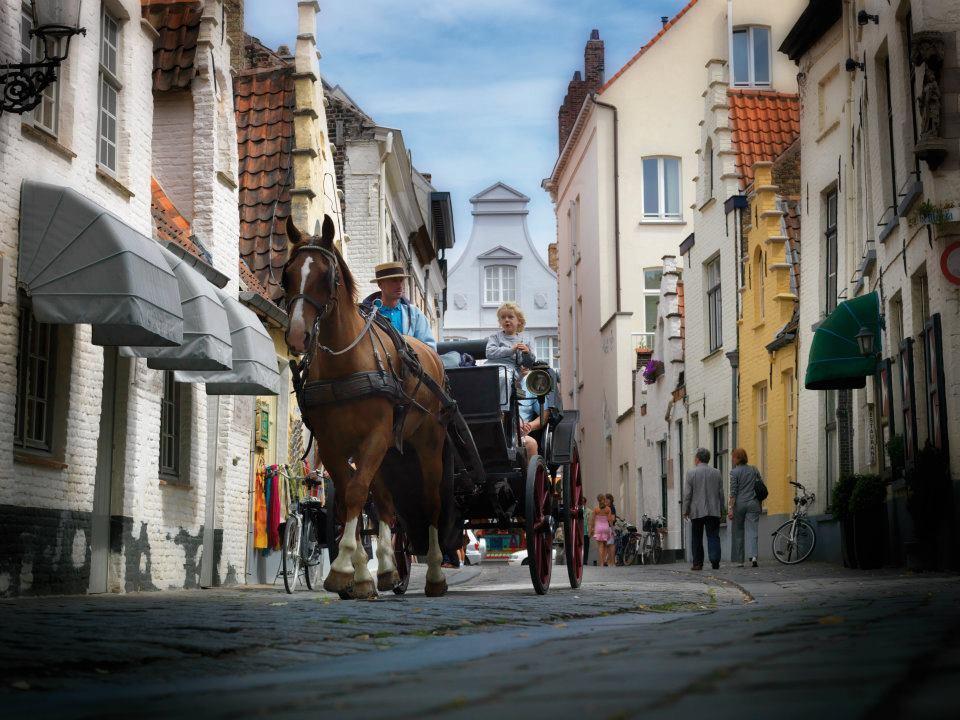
[{"left": 280, "top": 474, "right": 326, "bottom": 595}]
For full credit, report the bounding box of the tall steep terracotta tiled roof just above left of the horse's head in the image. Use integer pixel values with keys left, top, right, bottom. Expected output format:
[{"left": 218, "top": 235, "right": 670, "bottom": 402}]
[{"left": 233, "top": 65, "right": 295, "bottom": 301}]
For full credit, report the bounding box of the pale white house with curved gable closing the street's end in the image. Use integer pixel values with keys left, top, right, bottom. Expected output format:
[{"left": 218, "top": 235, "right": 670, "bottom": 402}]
[{"left": 443, "top": 183, "right": 559, "bottom": 367}]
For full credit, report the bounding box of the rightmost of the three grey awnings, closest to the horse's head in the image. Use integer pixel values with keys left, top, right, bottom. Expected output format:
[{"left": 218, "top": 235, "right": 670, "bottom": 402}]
[{"left": 174, "top": 290, "right": 280, "bottom": 395}]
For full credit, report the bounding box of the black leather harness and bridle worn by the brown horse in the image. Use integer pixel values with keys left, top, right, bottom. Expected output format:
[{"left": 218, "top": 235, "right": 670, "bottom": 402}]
[{"left": 288, "top": 245, "right": 457, "bottom": 457}]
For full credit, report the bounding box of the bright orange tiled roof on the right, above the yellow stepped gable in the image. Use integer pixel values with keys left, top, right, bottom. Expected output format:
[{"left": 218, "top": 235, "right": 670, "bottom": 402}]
[{"left": 727, "top": 89, "right": 800, "bottom": 188}]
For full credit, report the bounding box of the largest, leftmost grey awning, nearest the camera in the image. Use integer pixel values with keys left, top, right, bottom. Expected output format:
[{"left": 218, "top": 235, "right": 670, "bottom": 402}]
[{"left": 17, "top": 181, "right": 183, "bottom": 346}]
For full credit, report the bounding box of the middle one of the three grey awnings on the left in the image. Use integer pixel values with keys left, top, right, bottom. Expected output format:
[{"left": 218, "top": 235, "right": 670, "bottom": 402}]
[{"left": 120, "top": 248, "right": 233, "bottom": 370}]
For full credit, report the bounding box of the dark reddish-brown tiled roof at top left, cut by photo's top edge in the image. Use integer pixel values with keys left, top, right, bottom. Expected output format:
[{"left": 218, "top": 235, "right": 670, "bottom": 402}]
[{"left": 141, "top": 0, "right": 203, "bottom": 91}]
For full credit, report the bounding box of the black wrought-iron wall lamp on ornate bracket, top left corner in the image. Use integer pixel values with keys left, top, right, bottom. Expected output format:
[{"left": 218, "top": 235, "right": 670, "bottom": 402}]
[{"left": 0, "top": 0, "right": 87, "bottom": 114}]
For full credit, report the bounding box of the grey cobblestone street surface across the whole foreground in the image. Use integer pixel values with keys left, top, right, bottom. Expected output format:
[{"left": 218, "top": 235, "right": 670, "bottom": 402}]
[{"left": 0, "top": 564, "right": 960, "bottom": 719}]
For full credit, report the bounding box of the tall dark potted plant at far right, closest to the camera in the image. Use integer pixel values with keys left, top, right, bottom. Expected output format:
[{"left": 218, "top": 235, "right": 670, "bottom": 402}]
[{"left": 904, "top": 443, "right": 950, "bottom": 570}]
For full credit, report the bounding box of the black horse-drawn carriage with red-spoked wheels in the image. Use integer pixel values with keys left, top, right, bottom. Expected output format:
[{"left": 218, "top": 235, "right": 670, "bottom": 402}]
[{"left": 438, "top": 340, "right": 585, "bottom": 595}]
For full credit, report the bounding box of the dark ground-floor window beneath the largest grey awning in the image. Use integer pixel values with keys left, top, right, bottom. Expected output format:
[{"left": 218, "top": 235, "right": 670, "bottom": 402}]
[{"left": 13, "top": 296, "right": 57, "bottom": 453}]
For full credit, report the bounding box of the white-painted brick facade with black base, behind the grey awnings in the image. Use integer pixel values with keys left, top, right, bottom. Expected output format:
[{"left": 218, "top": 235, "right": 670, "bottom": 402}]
[{"left": 0, "top": 0, "right": 252, "bottom": 595}]
